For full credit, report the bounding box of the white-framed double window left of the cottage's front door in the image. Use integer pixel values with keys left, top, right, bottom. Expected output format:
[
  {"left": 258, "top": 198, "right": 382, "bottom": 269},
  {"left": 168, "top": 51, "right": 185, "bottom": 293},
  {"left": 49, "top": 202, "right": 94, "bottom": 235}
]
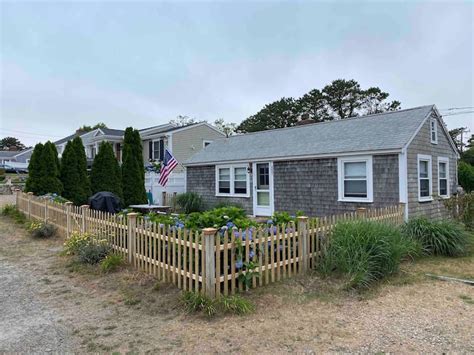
[{"left": 216, "top": 165, "right": 249, "bottom": 197}]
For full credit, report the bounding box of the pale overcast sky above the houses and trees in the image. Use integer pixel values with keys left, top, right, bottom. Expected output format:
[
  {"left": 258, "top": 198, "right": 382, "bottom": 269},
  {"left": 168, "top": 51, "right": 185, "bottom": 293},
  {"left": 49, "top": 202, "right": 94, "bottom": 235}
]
[{"left": 0, "top": 0, "right": 474, "bottom": 145}]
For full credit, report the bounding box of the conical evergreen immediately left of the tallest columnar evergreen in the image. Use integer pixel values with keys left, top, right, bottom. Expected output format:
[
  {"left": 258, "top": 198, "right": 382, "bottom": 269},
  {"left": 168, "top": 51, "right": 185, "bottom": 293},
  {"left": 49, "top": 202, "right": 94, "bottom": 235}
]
[{"left": 91, "top": 142, "right": 122, "bottom": 198}]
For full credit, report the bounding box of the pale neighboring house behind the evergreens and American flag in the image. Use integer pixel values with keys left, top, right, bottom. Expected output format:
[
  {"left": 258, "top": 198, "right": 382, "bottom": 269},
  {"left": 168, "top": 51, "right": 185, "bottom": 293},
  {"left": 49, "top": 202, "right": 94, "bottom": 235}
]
[{"left": 54, "top": 122, "right": 225, "bottom": 204}]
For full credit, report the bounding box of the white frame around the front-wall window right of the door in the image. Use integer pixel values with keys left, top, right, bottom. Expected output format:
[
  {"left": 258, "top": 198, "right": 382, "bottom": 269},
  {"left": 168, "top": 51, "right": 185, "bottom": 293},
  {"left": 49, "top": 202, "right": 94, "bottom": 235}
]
[{"left": 337, "top": 155, "right": 374, "bottom": 203}]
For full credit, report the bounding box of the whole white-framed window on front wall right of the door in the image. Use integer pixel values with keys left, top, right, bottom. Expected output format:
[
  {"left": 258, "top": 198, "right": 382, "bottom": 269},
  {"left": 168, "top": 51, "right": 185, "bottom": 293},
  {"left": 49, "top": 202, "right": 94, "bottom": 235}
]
[{"left": 338, "top": 156, "right": 373, "bottom": 202}]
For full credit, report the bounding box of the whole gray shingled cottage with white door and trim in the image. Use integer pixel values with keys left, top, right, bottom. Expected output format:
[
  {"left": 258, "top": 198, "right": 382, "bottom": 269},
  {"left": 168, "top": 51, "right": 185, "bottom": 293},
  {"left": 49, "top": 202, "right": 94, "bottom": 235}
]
[{"left": 185, "top": 105, "right": 459, "bottom": 221}]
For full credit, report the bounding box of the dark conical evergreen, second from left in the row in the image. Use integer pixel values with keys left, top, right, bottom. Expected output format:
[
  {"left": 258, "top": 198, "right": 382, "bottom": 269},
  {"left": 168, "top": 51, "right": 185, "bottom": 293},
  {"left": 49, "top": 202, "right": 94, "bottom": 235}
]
[{"left": 38, "top": 141, "right": 63, "bottom": 195}]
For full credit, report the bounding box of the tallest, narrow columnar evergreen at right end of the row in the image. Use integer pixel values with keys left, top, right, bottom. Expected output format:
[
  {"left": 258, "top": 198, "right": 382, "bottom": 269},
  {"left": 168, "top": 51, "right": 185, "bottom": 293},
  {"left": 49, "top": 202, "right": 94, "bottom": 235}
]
[{"left": 122, "top": 127, "right": 147, "bottom": 206}]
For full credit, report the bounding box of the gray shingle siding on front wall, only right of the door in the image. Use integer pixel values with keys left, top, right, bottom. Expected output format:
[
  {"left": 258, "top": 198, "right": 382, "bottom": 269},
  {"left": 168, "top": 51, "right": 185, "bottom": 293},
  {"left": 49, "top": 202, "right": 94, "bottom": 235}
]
[{"left": 274, "top": 155, "right": 399, "bottom": 216}]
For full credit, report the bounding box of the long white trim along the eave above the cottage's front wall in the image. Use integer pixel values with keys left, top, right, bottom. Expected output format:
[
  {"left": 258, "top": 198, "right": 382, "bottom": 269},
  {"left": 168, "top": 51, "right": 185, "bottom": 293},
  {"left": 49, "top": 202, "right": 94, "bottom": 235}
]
[{"left": 183, "top": 149, "right": 402, "bottom": 166}]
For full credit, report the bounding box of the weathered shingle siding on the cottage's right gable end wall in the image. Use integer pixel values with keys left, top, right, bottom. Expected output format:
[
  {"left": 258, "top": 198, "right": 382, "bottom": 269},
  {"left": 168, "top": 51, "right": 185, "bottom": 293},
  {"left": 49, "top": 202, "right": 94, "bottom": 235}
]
[{"left": 407, "top": 115, "right": 457, "bottom": 218}]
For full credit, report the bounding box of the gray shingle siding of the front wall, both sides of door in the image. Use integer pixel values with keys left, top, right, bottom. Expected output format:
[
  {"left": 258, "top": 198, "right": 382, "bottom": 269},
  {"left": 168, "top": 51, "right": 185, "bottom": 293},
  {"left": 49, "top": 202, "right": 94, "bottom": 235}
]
[{"left": 187, "top": 154, "right": 399, "bottom": 216}]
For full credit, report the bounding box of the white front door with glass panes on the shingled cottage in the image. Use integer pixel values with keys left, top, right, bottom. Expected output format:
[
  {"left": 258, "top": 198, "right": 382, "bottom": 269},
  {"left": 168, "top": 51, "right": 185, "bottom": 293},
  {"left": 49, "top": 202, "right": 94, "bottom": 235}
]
[{"left": 252, "top": 162, "right": 273, "bottom": 216}]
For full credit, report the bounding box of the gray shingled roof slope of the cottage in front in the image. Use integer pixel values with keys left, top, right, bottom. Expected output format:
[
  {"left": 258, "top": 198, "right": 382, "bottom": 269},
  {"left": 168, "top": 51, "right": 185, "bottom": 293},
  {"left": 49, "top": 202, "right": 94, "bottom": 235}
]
[{"left": 185, "top": 105, "right": 434, "bottom": 165}]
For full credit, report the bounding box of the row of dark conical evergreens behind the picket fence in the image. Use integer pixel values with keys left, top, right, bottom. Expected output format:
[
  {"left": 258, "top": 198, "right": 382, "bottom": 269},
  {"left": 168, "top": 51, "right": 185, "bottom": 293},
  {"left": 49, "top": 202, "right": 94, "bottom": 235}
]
[{"left": 25, "top": 127, "right": 147, "bottom": 206}]
